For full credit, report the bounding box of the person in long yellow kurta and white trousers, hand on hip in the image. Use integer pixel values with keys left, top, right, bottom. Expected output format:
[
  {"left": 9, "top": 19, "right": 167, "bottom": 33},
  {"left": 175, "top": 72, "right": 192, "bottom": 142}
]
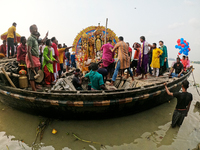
[{"left": 150, "top": 43, "right": 163, "bottom": 77}]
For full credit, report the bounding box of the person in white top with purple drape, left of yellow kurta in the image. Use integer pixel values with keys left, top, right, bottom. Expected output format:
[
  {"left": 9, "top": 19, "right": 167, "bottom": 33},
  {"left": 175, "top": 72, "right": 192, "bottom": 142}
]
[{"left": 137, "top": 36, "right": 152, "bottom": 79}]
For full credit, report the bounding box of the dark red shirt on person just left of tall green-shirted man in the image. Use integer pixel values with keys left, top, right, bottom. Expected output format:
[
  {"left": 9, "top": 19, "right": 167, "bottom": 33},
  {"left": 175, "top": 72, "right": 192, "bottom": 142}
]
[{"left": 17, "top": 44, "right": 27, "bottom": 62}]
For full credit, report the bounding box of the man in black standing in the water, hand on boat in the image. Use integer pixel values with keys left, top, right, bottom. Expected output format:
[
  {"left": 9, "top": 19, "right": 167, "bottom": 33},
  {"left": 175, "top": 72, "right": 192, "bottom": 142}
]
[{"left": 164, "top": 80, "right": 193, "bottom": 128}]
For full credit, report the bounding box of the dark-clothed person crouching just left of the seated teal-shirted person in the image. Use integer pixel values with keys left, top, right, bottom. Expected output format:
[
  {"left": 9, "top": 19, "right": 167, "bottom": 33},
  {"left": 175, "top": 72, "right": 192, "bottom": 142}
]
[{"left": 72, "top": 69, "right": 83, "bottom": 90}]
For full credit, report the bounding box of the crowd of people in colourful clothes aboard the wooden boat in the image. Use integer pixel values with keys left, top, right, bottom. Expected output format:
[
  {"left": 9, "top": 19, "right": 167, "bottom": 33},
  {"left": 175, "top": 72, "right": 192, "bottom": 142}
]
[{"left": 0, "top": 23, "right": 190, "bottom": 91}]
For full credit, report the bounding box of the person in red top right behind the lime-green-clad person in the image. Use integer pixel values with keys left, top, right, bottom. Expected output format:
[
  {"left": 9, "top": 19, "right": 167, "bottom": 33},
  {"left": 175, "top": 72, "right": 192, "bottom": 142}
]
[{"left": 51, "top": 37, "right": 60, "bottom": 81}]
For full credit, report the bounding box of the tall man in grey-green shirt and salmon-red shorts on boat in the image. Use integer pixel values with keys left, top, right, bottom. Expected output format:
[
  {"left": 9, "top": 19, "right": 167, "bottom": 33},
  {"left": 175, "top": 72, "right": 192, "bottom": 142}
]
[{"left": 26, "top": 24, "right": 41, "bottom": 91}]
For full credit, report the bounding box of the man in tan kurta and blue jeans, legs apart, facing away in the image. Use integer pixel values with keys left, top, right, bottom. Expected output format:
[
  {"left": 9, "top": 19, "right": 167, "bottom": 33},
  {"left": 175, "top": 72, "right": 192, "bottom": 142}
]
[{"left": 110, "top": 36, "right": 134, "bottom": 86}]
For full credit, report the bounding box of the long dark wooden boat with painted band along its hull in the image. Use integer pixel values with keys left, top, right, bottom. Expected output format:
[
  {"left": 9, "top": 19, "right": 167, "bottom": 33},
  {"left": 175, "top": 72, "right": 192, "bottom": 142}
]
[{"left": 0, "top": 60, "right": 192, "bottom": 119}]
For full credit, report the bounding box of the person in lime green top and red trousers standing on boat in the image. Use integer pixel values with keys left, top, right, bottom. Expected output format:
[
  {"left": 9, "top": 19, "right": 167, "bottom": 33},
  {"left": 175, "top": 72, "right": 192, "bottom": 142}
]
[{"left": 42, "top": 39, "right": 57, "bottom": 87}]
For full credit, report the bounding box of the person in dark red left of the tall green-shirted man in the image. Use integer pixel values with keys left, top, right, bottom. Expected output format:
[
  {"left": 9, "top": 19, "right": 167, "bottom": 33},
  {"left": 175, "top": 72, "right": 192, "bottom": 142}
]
[{"left": 17, "top": 36, "right": 27, "bottom": 64}]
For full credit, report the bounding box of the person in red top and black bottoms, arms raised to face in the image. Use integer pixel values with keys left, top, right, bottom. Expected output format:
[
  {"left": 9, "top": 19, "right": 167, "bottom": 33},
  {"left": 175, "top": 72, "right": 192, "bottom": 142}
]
[{"left": 131, "top": 43, "right": 141, "bottom": 75}]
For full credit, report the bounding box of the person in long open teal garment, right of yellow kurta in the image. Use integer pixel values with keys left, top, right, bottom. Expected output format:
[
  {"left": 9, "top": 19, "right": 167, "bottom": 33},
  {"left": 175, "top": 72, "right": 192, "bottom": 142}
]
[{"left": 159, "top": 41, "right": 169, "bottom": 76}]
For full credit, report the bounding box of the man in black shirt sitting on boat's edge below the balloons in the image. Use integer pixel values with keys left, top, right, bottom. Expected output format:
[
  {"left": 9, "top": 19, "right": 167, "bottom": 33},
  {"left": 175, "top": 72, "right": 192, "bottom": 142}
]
[{"left": 169, "top": 57, "right": 183, "bottom": 78}]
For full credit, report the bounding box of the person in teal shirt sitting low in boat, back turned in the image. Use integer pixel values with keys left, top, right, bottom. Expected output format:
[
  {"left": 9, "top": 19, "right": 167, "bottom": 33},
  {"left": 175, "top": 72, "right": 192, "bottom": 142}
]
[{"left": 85, "top": 63, "right": 107, "bottom": 90}]
